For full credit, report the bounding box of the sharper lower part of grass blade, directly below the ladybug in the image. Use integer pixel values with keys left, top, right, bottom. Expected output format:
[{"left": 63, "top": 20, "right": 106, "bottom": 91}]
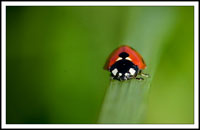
[{"left": 99, "top": 80, "right": 150, "bottom": 123}]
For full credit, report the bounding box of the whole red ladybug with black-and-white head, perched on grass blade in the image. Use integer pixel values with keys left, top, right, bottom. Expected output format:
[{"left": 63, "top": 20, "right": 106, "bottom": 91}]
[{"left": 104, "top": 45, "right": 149, "bottom": 81}]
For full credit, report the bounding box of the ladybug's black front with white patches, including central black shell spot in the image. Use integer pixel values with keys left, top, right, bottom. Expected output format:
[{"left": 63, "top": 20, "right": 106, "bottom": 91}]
[{"left": 110, "top": 52, "right": 139, "bottom": 80}]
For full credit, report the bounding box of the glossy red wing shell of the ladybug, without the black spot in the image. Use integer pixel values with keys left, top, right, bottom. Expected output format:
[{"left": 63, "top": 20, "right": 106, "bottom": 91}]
[{"left": 104, "top": 45, "right": 146, "bottom": 70}]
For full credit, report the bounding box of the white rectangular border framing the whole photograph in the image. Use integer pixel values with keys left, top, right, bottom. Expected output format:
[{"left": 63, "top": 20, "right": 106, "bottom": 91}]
[{"left": 1, "top": 1, "right": 199, "bottom": 129}]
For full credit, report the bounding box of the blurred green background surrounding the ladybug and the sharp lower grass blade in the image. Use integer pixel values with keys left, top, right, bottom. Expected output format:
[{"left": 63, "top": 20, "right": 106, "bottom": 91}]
[{"left": 6, "top": 6, "right": 194, "bottom": 124}]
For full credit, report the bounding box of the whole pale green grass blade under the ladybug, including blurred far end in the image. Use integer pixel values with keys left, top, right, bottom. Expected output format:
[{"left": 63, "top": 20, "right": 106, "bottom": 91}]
[{"left": 98, "top": 7, "right": 177, "bottom": 124}]
